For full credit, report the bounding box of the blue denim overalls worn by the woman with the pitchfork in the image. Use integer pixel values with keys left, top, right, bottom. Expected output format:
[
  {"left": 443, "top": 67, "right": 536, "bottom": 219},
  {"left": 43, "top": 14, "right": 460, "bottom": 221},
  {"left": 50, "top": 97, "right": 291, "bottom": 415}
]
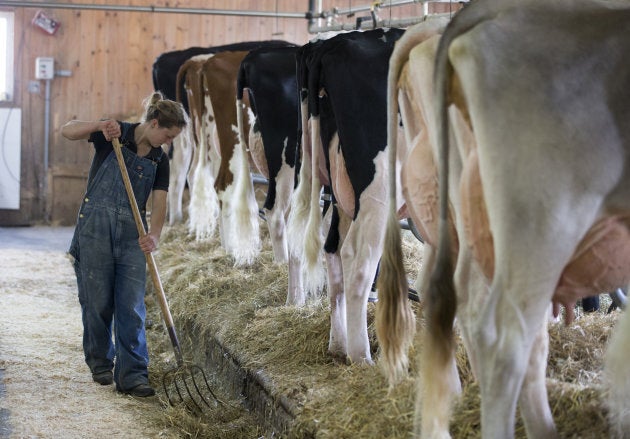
[{"left": 70, "top": 148, "right": 157, "bottom": 390}]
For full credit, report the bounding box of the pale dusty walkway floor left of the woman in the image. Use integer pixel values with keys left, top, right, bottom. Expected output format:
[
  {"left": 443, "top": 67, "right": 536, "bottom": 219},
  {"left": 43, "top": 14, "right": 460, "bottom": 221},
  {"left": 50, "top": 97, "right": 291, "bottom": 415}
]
[{"left": 0, "top": 229, "right": 180, "bottom": 438}]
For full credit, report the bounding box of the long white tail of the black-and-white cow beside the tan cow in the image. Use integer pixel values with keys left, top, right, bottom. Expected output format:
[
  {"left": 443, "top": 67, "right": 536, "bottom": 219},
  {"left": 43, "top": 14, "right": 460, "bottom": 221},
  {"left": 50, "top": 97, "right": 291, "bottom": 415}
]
[{"left": 303, "top": 116, "right": 326, "bottom": 293}]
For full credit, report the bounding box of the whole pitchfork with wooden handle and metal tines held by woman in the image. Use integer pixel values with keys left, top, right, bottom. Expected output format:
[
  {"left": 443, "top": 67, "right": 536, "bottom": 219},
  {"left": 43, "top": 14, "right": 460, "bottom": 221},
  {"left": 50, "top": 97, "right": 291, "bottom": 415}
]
[{"left": 112, "top": 138, "right": 221, "bottom": 413}]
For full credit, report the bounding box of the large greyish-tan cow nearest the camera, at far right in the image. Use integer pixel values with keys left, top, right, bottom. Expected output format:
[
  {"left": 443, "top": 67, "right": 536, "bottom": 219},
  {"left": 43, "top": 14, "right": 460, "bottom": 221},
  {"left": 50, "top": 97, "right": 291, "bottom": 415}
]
[{"left": 380, "top": 0, "right": 630, "bottom": 438}]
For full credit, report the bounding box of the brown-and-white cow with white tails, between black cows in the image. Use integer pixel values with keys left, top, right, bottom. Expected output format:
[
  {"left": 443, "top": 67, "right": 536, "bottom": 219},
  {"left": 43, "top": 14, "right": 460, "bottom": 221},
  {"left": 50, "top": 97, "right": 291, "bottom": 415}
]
[{"left": 178, "top": 50, "right": 260, "bottom": 264}]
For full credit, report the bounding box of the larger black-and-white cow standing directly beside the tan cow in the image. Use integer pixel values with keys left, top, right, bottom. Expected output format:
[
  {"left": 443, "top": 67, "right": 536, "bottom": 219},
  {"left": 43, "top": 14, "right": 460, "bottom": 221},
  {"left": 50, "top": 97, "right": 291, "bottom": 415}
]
[{"left": 288, "top": 29, "right": 404, "bottom": 364}]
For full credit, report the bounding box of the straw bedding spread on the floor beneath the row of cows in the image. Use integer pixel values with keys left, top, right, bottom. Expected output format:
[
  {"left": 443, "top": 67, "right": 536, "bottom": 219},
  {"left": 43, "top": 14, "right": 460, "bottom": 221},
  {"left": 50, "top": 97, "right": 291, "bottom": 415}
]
[{"left": 149, "top": 222, "right": 616, "bottom": 438}]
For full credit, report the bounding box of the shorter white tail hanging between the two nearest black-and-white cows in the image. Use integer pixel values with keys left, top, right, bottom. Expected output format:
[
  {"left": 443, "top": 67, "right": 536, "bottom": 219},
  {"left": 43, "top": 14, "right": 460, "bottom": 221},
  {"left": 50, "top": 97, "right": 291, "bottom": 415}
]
[{"left": 287, "top": 100, "right": 313, "bottom": 261}]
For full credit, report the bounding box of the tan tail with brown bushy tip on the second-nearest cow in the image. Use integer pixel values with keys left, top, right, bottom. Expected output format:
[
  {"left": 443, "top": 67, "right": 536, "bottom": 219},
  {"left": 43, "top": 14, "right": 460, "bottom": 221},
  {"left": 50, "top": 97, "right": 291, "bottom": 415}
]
[{"left": 376, "top": 31, "right": 416, "bottom": 387}]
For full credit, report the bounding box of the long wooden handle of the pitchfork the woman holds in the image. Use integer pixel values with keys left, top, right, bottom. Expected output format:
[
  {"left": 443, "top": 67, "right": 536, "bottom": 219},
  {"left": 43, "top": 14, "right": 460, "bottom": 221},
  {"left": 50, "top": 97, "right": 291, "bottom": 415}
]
[{"left": 112, "top": 138, "right": 184, "bottom": 367}]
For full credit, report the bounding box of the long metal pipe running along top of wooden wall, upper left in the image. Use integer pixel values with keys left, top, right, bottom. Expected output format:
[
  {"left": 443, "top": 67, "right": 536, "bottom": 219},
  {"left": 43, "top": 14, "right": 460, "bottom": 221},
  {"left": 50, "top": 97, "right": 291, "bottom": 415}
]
[{"left": 0, "top": 0, "right": 308, "bottom": 19}]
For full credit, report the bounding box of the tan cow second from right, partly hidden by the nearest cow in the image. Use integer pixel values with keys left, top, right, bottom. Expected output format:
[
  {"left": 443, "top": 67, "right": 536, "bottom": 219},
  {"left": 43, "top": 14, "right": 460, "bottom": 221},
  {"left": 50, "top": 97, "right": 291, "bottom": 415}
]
[{"left": 376, "top": 17, "right": 494, "bottom": 438}]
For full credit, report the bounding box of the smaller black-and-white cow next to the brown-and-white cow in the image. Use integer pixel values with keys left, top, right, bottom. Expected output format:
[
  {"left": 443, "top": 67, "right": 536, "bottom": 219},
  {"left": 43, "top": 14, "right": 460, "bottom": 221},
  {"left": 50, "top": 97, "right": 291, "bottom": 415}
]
[{"left": 236, "top": 47, "right": 306, "bottom": 305}]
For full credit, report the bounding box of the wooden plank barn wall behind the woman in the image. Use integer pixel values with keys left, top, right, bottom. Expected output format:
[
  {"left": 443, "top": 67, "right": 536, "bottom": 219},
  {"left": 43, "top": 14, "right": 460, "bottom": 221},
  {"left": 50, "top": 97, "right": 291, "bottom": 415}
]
[{"left": 0, "top": 0, "right": 464, "bottom": 226}]
